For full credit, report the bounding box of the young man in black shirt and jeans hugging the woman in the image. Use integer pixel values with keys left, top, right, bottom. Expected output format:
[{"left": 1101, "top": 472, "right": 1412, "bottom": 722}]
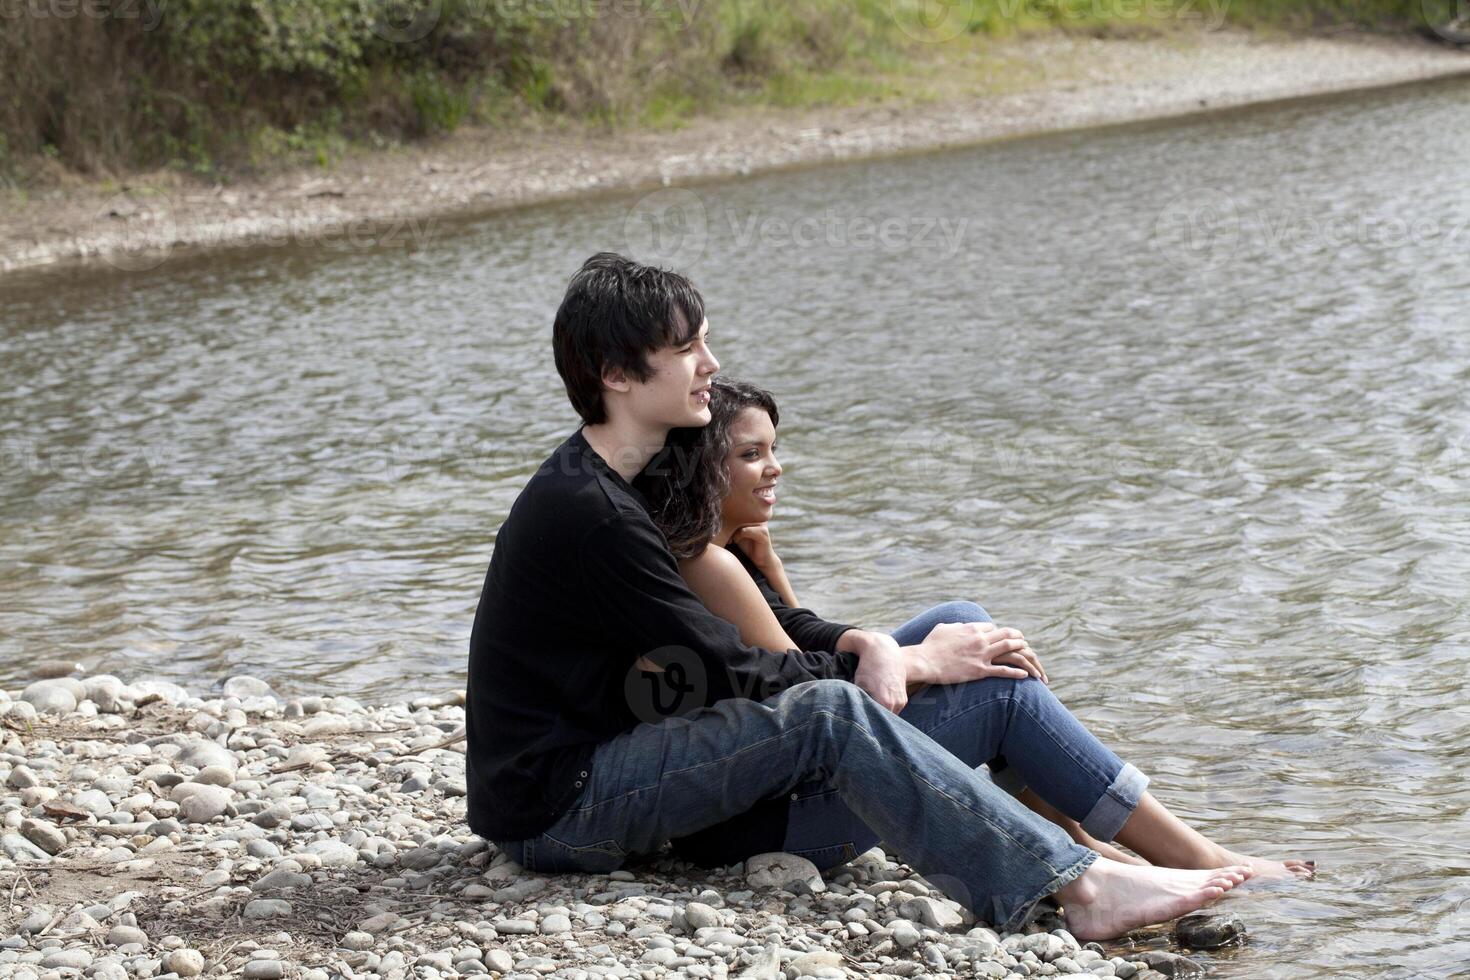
[{"left": 466, "top": 253, "right": 1250, "bottom": 939}]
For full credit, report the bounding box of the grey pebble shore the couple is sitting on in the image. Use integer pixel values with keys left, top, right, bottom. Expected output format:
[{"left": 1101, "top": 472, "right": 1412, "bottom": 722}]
[{"left": 0, "top": 674, "right": 1241, "bottom": 980}]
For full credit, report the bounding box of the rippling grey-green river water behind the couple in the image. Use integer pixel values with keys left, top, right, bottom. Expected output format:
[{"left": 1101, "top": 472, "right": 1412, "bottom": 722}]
[{"left": 0, "top": 74, "right": 1470, "bottom": 979}]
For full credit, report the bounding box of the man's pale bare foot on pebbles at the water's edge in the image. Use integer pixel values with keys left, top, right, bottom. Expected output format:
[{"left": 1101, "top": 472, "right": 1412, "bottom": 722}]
[{"left": 1055, "top": 858, "right": 1252, "bottom": 942}]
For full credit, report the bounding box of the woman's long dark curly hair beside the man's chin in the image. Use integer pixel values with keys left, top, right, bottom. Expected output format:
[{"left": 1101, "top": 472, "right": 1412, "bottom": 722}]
[{"left": 635, "top": 378, "right": 781, "bottom": 560}]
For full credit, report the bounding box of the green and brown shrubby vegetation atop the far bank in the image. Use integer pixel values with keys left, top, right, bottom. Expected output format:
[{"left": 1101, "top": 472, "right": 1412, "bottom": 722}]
[{"left": 0, "top": 0, "right": 1457, "bottom": 176}]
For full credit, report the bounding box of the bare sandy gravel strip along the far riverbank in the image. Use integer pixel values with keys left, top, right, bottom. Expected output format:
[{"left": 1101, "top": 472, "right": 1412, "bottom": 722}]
[{"left": 0, "top": 31, "right": 1470, "bottom": 275}]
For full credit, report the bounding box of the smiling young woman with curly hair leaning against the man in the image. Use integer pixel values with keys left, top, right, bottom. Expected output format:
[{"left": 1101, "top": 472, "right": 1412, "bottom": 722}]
[{"left": 639, "top": 378, "right": 1313, "bottom": 877}]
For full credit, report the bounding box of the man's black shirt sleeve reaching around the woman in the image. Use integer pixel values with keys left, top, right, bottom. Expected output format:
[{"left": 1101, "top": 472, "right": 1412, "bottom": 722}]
[{"left": 582, "top": 514, "right": 857, "bottom": 714}]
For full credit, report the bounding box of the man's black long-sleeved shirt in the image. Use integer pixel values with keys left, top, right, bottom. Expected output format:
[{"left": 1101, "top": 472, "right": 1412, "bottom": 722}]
[{"left": 465, "top": 429, "right": 857, "bottom": 840}]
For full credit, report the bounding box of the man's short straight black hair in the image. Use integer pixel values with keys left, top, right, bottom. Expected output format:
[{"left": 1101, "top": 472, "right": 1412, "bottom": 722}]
[{"left": 551, "top": 251, "right": 704, "bottom": 425}]
